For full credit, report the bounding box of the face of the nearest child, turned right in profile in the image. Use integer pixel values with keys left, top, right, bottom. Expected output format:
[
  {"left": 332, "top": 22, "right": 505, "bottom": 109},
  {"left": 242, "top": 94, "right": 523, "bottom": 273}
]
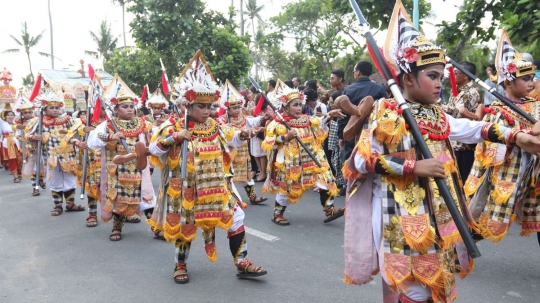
[{"left": 403, "top": 64, "right": 444, "bottom": 104}]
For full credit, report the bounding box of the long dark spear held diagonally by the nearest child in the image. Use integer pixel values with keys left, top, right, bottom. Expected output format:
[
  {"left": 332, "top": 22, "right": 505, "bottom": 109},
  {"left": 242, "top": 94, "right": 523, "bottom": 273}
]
[{"left": 349, "top": 0, "right": 481, "bottom": 259}]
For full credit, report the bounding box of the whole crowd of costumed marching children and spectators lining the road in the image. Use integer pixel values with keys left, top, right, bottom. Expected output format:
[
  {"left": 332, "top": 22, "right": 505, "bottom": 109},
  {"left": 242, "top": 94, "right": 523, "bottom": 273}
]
[{"left": 0, "top": 1, "right": 540, "bottom": 302}]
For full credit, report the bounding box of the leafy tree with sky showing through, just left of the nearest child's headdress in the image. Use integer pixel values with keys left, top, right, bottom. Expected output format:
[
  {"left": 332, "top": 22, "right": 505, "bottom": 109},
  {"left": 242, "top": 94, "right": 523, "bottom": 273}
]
[{"left": 270, "top": 0, "right": 431, "bottom": 84}]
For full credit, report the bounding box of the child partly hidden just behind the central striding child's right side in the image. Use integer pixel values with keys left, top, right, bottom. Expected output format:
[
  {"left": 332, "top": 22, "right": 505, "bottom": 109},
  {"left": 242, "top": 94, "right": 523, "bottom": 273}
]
[{"left": 218, "top": 80, "right": 268, "bottom": 204}]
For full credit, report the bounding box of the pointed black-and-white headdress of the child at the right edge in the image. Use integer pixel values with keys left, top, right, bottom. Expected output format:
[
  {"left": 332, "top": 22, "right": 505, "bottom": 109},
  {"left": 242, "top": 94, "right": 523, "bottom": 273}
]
[{"left": 495, "top": 28, "right": 536, "bottom": 83}]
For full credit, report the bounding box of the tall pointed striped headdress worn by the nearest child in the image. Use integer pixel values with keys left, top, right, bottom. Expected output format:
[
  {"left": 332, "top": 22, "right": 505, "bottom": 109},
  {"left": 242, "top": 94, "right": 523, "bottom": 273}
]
[{"left": 384, "top": 0, "right": 446, "bottom": 75}]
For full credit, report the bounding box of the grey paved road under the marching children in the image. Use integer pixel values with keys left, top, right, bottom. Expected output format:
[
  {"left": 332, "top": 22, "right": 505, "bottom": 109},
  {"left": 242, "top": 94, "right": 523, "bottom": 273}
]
[{"left": 0, "top": 170, "right": 540, "bottom": 303}]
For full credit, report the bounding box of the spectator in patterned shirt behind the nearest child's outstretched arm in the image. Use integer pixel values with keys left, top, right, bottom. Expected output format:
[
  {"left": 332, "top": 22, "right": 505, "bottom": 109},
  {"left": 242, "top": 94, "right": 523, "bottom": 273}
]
[{"left": 441, "top": 61, "right": 485, "bottom": 182}]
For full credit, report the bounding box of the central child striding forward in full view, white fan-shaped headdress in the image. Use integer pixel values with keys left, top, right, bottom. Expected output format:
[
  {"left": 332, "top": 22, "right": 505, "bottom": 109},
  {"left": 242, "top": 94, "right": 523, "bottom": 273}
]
[{"left": 149, "top": 50, "right": 266, "bottom": 284}]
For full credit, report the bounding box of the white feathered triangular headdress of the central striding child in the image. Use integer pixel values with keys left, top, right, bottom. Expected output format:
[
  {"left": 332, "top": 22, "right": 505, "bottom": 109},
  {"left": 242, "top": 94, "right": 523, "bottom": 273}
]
[{"left": 173, "top": 50, "right": 220, "bottom": 104}]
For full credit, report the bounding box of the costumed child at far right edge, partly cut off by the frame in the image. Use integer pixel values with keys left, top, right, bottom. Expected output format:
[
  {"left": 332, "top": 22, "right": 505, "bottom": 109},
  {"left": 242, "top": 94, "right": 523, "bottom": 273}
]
[{"left": 465, "top": 29, "right": 540, "bottom": 242}]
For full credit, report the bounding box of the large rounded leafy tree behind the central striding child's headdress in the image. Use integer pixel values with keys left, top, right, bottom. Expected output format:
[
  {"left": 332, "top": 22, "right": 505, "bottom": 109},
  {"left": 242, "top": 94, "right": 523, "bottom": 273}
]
[{"left": 117, "top": 0, "right": 251, "bottom": 83}]
